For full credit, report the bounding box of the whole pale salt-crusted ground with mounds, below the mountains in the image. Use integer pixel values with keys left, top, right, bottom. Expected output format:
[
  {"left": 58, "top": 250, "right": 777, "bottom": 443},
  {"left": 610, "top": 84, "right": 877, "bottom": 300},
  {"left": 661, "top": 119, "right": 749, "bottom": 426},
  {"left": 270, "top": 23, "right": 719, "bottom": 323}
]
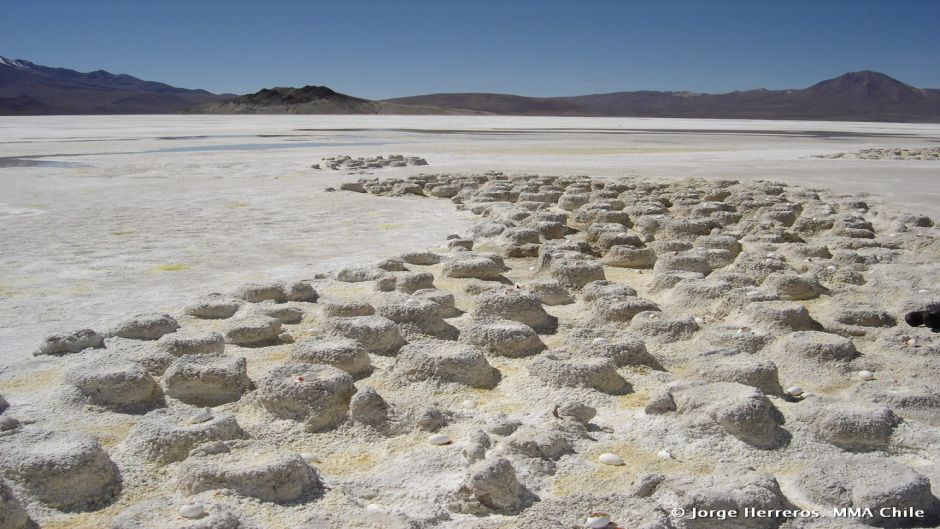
[{"left": 0, "top": 116, "right": 940, "bottom": 529}]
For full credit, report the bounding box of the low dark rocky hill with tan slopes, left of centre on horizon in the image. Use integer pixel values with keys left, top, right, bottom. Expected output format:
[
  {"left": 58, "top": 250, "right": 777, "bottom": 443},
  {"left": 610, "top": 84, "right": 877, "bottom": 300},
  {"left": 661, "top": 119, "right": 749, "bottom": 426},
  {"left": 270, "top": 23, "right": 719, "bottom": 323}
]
[{"left": 191, "top": 86, "right": 477, "bottom": 114}]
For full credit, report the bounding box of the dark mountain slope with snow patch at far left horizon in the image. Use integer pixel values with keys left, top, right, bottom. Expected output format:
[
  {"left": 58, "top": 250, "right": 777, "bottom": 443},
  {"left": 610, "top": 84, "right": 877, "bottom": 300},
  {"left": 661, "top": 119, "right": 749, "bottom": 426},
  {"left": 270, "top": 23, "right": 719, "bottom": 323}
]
[{"left": 0, "top": 57, "right": 231, "bottom": 116}]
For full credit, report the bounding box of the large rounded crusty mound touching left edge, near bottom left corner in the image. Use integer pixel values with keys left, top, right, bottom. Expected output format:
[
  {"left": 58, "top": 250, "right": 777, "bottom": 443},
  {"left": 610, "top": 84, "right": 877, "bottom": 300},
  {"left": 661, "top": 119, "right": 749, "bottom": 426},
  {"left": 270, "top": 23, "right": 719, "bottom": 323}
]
[{"left": 0, "top": 430, "right": 121, "bottom": 511}]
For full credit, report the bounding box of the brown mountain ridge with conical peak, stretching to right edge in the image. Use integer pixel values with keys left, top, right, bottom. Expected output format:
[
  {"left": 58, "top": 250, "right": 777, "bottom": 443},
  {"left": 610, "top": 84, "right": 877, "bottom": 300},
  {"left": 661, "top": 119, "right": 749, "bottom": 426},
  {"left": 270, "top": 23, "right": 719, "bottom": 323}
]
[{"left": 388, "top": 71, "right": 940, "bottom": 122}]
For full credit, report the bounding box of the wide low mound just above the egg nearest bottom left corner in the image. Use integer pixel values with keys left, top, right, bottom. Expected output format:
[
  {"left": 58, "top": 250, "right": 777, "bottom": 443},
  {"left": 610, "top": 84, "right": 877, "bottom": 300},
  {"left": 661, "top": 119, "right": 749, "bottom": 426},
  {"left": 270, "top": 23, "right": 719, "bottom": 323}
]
[{"left": 177, "top": 441, "right": 323, "bottom": 503}]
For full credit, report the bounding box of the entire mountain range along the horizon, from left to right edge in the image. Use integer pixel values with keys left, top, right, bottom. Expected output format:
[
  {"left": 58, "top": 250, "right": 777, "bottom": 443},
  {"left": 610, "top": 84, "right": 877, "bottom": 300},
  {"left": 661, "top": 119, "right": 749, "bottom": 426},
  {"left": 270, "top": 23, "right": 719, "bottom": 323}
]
[{"left": 0, "top": 57, "right": 940, "bottom": 123}]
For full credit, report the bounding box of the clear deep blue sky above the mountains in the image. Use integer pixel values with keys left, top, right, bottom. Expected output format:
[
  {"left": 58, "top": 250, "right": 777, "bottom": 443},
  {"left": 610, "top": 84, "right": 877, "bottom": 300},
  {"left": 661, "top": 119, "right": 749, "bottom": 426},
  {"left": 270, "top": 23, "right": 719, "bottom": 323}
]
[{"left": 0, "top": 0, "right": 940, "bottom": 99}]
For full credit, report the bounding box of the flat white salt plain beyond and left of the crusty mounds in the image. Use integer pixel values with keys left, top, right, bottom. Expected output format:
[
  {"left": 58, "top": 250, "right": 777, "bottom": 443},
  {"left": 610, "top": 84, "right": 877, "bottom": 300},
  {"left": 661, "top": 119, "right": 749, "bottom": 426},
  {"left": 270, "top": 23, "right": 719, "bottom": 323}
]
[{"left": 0, "top": 116, "right": 940, "bottom": 364}]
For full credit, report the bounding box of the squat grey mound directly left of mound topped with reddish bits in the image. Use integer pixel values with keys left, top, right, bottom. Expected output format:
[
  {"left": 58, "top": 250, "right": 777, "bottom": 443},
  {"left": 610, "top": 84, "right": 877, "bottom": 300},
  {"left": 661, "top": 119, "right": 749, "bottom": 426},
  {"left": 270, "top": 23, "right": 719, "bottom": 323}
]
[{"left": 163, "top": 354, "right": 254, "bottom": 406}]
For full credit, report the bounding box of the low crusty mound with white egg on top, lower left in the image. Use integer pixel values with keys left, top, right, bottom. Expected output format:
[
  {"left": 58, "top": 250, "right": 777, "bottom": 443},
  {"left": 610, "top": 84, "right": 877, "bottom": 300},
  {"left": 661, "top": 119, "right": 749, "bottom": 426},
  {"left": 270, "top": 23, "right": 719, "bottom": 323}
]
[{"left": 120, "top": 408, "right": 248, "bottom": 465}]
